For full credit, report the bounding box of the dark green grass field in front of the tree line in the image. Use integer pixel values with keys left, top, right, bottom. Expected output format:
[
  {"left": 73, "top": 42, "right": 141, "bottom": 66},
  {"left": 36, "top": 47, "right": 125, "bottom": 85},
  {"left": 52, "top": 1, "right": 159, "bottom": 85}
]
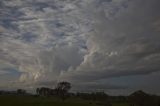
[{"left": 0, "top": 96, "right": 128, "bottom": 106}]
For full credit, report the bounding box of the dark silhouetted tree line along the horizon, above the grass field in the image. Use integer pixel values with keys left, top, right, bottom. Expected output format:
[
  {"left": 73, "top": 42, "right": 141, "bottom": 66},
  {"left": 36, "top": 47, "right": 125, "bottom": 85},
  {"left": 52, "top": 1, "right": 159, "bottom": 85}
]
[{"left": 0, "top": 81, "right": 160, "bottom": 106}]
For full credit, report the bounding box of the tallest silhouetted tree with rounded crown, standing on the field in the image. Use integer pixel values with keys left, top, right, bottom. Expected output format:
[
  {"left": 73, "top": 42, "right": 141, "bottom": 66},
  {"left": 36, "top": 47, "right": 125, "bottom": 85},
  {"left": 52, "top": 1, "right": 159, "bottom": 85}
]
[{"left": 55, "top": 81, "right": 71, "bottom": 101}]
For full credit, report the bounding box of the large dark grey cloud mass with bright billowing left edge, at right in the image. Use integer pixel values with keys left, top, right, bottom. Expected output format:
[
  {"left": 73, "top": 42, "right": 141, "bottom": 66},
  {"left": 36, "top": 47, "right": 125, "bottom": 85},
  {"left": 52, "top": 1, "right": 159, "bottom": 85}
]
[{"left": 59, "top": 0, "right": 160, "bottom": 88}]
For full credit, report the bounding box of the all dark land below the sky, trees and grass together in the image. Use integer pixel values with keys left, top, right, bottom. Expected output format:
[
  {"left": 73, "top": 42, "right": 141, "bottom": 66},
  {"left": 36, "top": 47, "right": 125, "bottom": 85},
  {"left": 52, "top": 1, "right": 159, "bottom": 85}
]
[{"left": 0, "top": 82, "right": 160, "bottom": 106}]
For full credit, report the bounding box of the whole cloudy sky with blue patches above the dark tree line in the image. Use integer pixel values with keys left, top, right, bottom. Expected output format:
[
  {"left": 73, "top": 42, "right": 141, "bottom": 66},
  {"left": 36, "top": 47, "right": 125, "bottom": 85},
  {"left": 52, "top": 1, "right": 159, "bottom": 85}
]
[{"left": 0, "top": 0, "right": 160, "bottom": 95}]
